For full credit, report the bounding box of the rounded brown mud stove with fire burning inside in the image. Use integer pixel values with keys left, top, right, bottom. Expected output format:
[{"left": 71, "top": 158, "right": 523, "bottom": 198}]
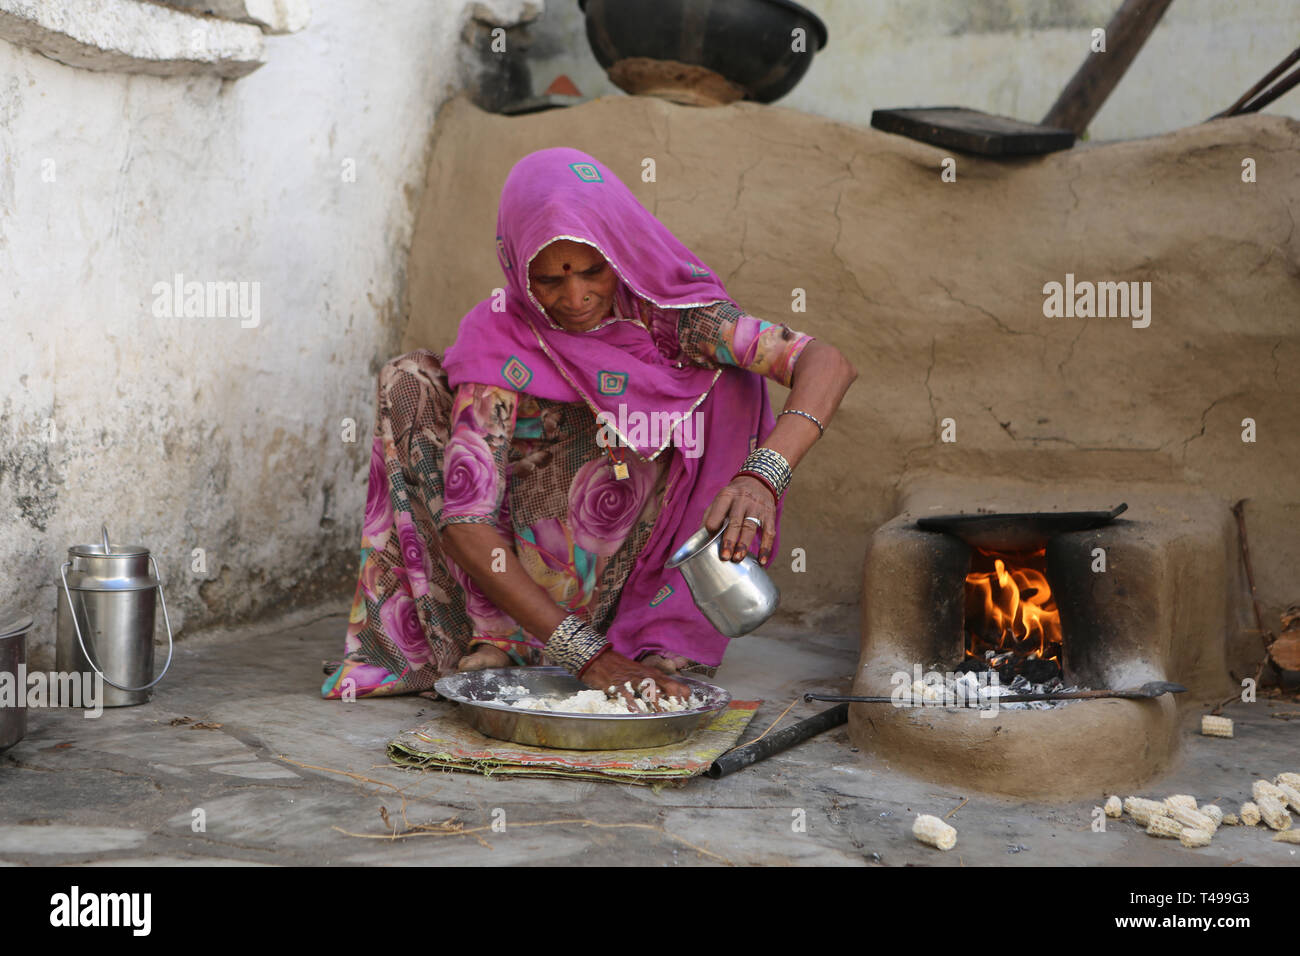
[{"left": 849, "top": 494, "right": 1240, "bottom": 799}]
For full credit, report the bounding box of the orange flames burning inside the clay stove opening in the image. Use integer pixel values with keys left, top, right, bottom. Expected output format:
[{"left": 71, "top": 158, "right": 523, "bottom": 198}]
[{"left": 959, "top": 548, "right": 1063, "bottom": 684}]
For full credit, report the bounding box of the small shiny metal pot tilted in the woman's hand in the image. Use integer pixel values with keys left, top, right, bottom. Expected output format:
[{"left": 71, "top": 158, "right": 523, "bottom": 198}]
[{"left": 664, "top": 522, "right": 781, "bottom": 637}]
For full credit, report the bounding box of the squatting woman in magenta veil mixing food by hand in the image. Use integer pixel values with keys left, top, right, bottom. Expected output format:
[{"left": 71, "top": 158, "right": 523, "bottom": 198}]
[{"left": 321, "top": 148, "right": 857, "bottom": 698}]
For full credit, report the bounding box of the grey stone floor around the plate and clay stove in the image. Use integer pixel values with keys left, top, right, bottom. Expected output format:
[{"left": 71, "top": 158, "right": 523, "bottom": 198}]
[{"left": 0, "top": 615, "right": 1300, "bottom": 866}]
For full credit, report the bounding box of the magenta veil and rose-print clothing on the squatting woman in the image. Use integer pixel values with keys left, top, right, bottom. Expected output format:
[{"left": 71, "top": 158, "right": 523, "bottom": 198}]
[{"left": 322, "top": 150, "right": 780, "bottom": 698}]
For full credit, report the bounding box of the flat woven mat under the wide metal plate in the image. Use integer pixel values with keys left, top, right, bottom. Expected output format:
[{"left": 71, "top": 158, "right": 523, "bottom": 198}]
[{"left": 389, "top": 700, "right": 763, "bottom": 786}]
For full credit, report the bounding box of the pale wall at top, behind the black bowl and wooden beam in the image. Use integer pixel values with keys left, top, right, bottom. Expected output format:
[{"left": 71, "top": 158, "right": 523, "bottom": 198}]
[{"left": 533, "top": 0, "right": 1300, "bottom": 140}]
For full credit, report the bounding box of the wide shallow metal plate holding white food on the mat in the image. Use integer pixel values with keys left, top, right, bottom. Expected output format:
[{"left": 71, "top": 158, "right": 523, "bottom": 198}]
[{"left": 434, "top": 667, "right": 731, "bottom": 750}]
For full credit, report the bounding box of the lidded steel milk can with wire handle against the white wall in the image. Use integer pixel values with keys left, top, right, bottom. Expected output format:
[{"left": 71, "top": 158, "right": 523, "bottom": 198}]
[{"left": 55, "top": 528, "right": 173, "bottom": 708}]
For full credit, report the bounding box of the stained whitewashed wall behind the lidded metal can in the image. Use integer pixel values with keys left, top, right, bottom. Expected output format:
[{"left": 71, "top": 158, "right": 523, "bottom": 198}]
[{"left": 0, "top": 0, "right": 537, "bottom": 661}]
